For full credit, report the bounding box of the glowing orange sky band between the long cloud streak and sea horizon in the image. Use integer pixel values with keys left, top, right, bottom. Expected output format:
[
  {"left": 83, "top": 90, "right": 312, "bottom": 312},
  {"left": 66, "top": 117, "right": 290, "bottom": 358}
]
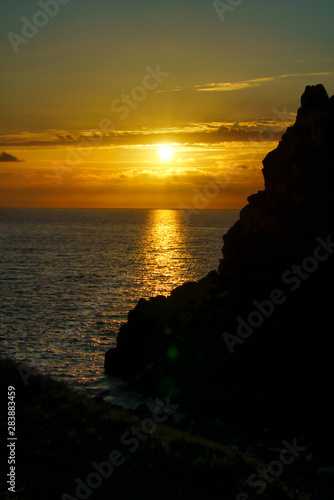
[{"left": 0, "top": 136, "right": 290, "bottom": 210}]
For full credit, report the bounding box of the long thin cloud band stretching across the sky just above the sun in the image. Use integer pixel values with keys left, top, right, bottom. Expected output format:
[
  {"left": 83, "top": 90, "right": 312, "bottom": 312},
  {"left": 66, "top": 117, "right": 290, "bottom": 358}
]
[{"left": 0, "top": 114, "right": 296, "bottom": 151}]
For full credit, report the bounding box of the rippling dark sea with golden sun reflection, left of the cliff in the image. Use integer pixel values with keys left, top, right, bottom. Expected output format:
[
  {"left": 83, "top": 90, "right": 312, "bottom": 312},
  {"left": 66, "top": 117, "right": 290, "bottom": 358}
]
[{"left": 0, "top": 209, "right": 239, "bottom": 407}]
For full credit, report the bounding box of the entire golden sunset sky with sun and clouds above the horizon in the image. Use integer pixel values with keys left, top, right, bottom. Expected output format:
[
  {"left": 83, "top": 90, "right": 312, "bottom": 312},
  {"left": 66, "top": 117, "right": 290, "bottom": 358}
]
[{"left": 0, "top": 0, "right": 334, "bottom": 207}]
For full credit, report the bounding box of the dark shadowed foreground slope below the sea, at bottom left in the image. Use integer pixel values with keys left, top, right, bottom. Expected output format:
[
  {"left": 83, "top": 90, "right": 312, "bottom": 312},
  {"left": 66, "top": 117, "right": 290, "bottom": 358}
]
[{"left": 0, "top": 359, "right": 301, "bottom": 500}]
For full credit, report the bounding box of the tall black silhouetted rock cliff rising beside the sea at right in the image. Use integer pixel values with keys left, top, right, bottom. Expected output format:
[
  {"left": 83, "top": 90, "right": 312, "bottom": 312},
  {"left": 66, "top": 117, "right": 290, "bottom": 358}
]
[{"left": 105, "top": 85, "right": 334, "bottom": 428}]
